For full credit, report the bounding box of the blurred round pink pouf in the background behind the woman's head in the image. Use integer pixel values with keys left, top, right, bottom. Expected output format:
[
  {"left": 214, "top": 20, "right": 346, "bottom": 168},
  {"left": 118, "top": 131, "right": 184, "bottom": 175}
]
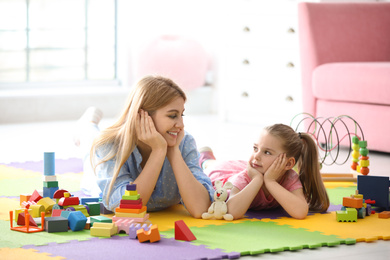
[{"left": 136, "top": 35, "right": 209, "bottom": 90}]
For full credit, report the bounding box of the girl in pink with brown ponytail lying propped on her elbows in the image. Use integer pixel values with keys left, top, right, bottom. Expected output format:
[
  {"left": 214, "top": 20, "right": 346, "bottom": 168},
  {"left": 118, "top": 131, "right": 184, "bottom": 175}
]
[{"left": 200, "top": 124, "right": 329, "bottom": 219}]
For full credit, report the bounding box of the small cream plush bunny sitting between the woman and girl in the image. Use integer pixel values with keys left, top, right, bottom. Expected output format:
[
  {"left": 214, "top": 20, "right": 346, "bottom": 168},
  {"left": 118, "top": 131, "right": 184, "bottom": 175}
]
[{"left": 202, "top": 181, "right": 233, "bottom": 220}]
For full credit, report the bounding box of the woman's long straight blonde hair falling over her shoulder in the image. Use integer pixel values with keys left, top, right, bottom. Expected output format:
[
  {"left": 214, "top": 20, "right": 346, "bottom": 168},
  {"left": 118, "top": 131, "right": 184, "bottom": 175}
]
[{"left": 90, "top": 76, "right": 187, "bottom": 203}]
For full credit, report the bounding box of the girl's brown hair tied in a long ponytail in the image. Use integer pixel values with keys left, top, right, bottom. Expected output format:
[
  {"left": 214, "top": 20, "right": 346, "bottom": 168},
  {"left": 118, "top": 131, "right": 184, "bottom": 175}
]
[{"left": 265, "top": 124, "right": 329, "bottom": 212}]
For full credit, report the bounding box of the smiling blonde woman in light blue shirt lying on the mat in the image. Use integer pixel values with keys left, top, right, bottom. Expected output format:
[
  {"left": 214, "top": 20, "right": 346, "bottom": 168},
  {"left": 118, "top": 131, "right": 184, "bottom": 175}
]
[{"left": 76, "top": 76, "right": 214, "bottom": 218}]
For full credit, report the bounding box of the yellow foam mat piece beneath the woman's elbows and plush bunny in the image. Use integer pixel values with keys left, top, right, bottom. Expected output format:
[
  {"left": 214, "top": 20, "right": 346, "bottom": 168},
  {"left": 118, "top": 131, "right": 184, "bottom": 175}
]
[{"left": 149, "top": 205, "right": 248, "bottom": 231}]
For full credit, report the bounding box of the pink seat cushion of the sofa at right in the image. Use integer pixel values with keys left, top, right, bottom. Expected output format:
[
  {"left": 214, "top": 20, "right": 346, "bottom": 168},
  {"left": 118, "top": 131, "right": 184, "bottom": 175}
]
[{"left": 313, "top": 62, "right": 390, "bottom": 105}]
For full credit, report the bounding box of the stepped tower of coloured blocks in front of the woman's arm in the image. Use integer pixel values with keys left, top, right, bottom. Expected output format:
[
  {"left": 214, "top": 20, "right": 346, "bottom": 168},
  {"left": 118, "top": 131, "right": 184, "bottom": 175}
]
[{"left": 112, "top": 184, "right": 149, "bottom": 222}]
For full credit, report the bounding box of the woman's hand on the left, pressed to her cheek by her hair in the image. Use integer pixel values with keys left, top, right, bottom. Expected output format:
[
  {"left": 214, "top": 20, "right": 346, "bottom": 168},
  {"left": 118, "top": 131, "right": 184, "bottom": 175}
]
[{"left": 136, "top": 109, "right": 168, "bottom": 150}]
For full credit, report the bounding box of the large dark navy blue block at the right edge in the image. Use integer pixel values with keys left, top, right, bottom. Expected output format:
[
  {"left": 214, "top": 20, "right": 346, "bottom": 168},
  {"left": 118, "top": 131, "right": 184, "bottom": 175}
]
[{"left": 357, "top": 175, "right": 390, "bottom": 210}]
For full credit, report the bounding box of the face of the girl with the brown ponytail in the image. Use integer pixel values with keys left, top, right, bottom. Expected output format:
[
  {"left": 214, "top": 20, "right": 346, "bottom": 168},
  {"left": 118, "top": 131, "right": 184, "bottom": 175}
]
[{"left": 249, "top": 130, "right": 285, "bottom": 174}]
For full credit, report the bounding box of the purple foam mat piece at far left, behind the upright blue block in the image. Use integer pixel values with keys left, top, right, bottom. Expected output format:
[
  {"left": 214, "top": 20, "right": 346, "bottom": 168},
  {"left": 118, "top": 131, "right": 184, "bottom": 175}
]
[{"left": 6, "top": 158, "right": 83, "bottom": 174}]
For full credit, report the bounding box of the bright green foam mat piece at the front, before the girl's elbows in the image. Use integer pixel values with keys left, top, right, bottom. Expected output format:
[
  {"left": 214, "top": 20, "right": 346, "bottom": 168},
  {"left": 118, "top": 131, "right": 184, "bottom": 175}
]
[{"left": 161, "top": 221, "right": 356, "bottom": 255}]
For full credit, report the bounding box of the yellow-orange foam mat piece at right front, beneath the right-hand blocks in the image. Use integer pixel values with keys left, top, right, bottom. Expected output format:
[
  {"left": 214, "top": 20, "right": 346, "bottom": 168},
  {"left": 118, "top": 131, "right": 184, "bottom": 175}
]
[{"left": 262, "top": 212, "right": 390, "bottom": 242}]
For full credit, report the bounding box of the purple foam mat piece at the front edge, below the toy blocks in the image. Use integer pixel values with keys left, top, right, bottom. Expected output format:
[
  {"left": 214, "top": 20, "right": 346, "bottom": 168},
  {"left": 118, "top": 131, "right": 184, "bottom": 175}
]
[{"left": 23, "top": 236, "right": 241, "bottom": 260}]
